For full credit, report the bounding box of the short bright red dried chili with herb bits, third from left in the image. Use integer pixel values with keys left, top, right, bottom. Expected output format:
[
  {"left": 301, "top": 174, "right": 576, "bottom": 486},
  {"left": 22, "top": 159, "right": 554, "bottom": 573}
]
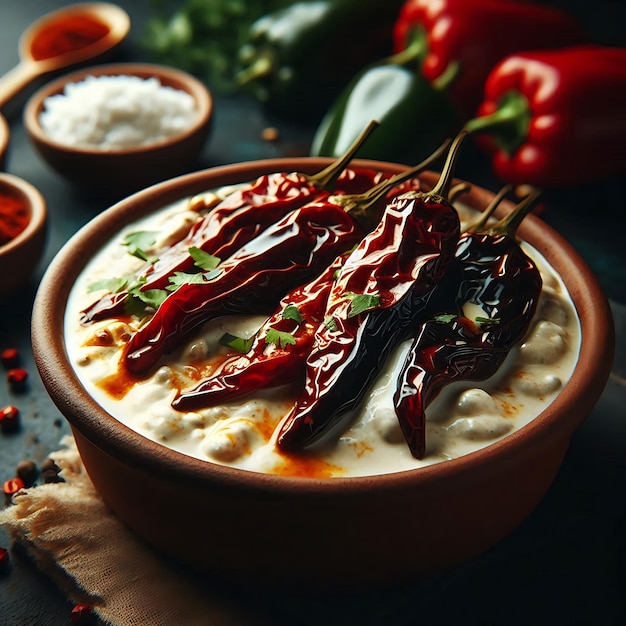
[{"left": 172, "top": 255, "right": 346, "bottom": 411}]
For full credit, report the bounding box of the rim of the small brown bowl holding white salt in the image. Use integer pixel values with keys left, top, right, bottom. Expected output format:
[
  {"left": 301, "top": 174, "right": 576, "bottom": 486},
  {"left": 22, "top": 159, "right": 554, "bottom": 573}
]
[{"left": 23, "top": 62, "right": 214, "bottom": 158}]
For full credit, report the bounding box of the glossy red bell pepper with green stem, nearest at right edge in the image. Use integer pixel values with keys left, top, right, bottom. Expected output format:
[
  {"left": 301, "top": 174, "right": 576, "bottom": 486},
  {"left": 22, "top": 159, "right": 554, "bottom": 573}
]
[{"left": 466, "top": 45, "right": 626, "bottom": 188}]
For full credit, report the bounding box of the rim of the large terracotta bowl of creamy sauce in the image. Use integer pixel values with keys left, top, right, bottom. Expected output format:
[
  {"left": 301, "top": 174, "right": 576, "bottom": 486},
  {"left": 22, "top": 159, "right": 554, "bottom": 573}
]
[{"left": 32, "top": 157, "right": 615, "bottom": 498}]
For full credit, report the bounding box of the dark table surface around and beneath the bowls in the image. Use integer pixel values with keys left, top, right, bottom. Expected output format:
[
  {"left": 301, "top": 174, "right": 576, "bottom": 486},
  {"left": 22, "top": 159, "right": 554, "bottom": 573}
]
[{"left": 0, "top": 0, "right": 626, "bottom": 626}]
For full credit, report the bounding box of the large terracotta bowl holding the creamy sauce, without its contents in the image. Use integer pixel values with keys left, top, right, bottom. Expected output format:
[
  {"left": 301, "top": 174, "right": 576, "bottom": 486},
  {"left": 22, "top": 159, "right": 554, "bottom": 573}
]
[{"left": 33, "top": 158, "right": 614, "bottom": 585}]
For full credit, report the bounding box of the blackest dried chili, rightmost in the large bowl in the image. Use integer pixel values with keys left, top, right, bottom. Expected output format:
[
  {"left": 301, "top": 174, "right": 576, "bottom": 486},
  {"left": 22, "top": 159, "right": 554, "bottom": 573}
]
[{"left": 394, "top": 188, "right": 542, "bottom": 459}]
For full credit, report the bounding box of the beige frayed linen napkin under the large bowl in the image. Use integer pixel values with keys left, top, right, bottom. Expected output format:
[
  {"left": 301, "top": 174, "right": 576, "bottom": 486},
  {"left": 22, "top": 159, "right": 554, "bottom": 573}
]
[{"left": 0, "top": 438, "right": 258, "bottom": 626}]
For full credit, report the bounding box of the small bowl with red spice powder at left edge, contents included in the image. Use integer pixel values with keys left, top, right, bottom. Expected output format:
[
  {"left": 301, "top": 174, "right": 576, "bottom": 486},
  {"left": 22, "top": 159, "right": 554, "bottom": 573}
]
[{"left": 0, "top": 173, "right": 47, "bottom": 296}]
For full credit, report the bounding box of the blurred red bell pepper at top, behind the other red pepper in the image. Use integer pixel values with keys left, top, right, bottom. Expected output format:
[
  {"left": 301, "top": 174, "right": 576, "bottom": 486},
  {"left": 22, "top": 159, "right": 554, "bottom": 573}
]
[{"left": 394, "top": 0, "right": 585, "bottom": 121}]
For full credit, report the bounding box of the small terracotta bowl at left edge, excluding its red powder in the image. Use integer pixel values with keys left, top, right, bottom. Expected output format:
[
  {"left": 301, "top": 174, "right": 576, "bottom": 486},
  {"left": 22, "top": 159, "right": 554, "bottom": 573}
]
[{"left": 0, "top": 173, "right": 47, "bottom": 296}]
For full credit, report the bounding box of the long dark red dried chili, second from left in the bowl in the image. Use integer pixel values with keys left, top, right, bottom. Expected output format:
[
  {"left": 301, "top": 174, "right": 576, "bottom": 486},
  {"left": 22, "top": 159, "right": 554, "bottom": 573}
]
[{"left": 124, "top": 146, "right": 445, "bottom": 375}]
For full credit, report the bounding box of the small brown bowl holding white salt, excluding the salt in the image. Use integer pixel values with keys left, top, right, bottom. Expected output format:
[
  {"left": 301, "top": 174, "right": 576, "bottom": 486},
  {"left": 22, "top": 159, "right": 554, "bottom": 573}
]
[{"left": 24, "top": 63, "right": 213, "bottom": 193}]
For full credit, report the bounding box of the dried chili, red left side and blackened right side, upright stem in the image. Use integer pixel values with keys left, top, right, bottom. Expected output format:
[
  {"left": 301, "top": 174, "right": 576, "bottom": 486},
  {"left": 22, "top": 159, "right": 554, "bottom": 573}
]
[{"left": 277, "top": 134, "right": 464, "bottom": 451}]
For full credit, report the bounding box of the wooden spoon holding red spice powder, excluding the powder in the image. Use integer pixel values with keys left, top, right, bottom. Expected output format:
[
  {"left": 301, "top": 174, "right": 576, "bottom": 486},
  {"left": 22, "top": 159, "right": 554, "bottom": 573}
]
[{"left": 0, "top": 2, "right": 130, "bottom": 108}]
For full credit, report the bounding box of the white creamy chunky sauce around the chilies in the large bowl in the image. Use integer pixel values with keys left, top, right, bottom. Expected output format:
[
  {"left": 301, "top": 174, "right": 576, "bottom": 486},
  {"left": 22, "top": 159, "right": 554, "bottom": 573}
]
[{"left": 65, "top": 193, "right": 580, "bottom": 476}]
